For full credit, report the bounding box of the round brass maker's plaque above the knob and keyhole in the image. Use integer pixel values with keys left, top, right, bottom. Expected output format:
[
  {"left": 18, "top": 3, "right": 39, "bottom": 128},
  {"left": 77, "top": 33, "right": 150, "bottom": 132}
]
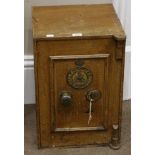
[{"left": 67, "top": 67, "right": 93, "bottom": 89}]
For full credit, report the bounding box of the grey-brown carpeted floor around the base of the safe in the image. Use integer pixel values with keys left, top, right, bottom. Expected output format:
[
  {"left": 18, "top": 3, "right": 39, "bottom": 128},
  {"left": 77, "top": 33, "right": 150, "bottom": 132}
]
[{"left": 24, "top": 101, "right": 131, "bottom": 155}]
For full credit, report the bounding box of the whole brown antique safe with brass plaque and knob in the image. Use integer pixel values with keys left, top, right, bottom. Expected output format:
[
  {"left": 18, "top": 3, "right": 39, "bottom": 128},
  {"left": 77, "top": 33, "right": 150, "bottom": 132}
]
[{"left": 32, "top": 4, "right": 126, "bottom": 149}]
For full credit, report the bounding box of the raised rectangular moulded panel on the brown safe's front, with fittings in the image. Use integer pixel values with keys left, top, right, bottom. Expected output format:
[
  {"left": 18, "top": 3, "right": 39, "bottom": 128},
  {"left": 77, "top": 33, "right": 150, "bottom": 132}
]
[{"left": 49, "top": 54, "right": 109, "bottom": 132}]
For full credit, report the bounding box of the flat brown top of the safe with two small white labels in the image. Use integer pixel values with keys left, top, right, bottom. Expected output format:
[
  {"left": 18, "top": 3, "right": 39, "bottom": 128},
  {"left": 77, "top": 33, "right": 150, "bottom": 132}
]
[{"left": 32, "top": 4, "right": 125, "bottom": 40}]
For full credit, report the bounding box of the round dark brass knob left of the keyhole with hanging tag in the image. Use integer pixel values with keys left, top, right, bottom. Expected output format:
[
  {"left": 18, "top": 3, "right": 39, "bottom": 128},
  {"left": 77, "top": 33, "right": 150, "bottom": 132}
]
[{"left": 60, "top": 91, "right": 72, "bottom": 107}]
